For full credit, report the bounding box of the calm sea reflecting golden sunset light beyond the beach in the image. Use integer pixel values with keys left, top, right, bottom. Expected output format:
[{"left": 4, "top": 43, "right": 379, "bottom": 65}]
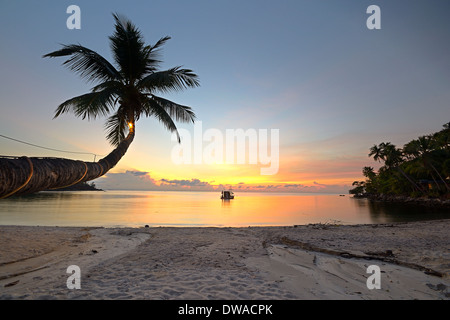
[{"left": 0, "top": 191, "right": 450, "bottom": 227}]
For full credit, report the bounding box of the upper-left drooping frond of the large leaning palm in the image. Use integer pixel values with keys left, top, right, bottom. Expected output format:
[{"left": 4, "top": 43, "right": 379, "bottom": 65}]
[{"left": 43, "top": 44, "right": 121, "bottom": 82}]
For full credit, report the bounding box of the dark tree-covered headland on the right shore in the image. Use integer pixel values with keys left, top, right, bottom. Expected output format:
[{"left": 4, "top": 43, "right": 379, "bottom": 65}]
[{"left": 349, "top": 122, "right": 450, "bottom": 199}]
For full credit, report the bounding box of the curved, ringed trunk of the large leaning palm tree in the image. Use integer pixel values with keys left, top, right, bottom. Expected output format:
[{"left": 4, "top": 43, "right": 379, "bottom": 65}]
[{"left": 0, "top": 130, "right": 134, "bottom": 199}]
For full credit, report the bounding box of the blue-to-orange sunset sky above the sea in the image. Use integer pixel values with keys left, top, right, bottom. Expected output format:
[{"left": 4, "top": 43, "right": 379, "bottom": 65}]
[{"left": 0, "top": 0, "right": 450, "bottom": 193}]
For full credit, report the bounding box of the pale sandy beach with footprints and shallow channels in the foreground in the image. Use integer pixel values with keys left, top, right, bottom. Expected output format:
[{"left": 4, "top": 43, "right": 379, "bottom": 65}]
[{"left": 0, "top": 220, "right": 450, "bottom": 300}]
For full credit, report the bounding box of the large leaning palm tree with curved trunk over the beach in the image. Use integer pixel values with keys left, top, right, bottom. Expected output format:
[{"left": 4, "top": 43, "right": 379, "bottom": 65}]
[{"left": 0, "top": 14, "right": 199, "bottom": 198}]
